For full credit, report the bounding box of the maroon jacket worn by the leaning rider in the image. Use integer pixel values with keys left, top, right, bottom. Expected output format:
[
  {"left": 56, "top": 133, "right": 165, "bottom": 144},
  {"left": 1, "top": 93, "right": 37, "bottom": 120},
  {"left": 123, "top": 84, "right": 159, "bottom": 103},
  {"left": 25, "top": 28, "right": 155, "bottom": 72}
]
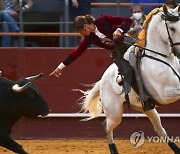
[{"left": 63, "top": 15, "right": 133, "bottom": 66}]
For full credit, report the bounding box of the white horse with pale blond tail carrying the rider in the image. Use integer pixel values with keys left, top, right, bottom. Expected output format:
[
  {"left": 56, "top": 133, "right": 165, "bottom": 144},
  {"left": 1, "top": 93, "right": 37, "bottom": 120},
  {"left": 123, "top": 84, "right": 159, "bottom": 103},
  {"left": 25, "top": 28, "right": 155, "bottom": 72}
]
[{"left": 79, "top": 6, "right": 180, "bottom": 154}]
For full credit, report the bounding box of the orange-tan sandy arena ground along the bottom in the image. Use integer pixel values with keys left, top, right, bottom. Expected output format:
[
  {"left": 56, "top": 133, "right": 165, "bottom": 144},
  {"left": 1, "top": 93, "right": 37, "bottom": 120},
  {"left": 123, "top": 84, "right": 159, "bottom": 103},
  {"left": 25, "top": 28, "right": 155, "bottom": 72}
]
[{"left": 0, "top": 140, "right": 180, "bottom": 154}]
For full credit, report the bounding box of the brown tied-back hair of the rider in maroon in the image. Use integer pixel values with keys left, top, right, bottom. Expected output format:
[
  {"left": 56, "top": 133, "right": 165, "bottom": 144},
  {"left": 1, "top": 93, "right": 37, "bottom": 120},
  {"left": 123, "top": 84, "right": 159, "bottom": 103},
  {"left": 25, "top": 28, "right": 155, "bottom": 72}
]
[{"left": 73, "top": 15, "right": 95, "bottom": 32}]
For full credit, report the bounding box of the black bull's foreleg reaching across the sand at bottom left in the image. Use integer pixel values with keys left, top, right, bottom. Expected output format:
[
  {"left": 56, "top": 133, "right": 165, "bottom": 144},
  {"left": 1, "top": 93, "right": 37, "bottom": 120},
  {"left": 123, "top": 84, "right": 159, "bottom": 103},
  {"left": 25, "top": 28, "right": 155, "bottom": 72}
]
[{"left": 0, "top": 132, "right": 28, "bottom": 154}]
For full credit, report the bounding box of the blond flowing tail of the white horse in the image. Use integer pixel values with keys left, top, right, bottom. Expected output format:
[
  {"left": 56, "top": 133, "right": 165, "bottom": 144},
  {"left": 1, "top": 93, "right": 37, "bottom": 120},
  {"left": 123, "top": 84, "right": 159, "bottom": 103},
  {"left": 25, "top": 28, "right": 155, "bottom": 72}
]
[{"left": 81, "top": 81, "right": 102, "bottom": 120}]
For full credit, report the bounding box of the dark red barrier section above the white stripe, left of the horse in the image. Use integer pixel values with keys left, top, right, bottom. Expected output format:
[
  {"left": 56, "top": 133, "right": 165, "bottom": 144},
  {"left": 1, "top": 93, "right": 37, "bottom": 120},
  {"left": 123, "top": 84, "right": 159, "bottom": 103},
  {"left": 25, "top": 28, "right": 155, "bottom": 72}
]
[{"left": 0, "top": 48, "right": 110, "bottom": 113}]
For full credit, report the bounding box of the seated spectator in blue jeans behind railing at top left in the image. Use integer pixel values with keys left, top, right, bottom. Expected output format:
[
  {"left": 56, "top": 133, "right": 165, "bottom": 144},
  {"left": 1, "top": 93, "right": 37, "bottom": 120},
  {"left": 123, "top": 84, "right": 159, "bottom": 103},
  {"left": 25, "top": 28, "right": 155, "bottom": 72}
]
[{"left": 0, "top": 0, "right": 33, "bottom": 47}]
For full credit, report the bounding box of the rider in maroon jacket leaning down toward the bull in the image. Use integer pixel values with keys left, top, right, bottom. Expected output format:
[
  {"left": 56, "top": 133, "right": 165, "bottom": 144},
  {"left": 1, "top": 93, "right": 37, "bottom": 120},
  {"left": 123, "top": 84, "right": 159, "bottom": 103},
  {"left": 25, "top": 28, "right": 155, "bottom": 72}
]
[{"left": 50, "top": 12, "right": 154, "bottom": 110}]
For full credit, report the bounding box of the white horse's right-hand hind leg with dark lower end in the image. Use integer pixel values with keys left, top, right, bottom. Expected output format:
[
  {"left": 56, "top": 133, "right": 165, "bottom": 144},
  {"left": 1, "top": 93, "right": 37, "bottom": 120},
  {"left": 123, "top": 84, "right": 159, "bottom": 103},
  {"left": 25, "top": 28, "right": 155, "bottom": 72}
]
[{"left": 145, "top": 109, "right": 180, "bottom": 154}]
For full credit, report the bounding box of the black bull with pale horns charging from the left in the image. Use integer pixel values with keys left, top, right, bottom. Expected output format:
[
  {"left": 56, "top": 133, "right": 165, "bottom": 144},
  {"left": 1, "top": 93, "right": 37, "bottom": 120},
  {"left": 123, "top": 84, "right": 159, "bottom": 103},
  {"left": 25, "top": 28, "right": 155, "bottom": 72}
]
[{"left": 0, "top": 74, "right": 50, "bottom": 154}]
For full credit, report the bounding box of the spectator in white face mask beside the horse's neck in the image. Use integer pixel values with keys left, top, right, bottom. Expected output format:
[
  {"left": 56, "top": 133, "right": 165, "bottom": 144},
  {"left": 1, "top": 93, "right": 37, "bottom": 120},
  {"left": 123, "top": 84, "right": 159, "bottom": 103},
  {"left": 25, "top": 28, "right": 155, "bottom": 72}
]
[{"left": 128, "top": 3, "right": 146, "bottom": 38}]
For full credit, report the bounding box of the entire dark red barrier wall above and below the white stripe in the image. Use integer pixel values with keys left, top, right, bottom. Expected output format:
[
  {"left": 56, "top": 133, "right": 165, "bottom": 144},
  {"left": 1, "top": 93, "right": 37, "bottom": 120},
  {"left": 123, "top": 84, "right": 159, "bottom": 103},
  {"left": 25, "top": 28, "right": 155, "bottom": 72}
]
[{"left": 0, "top": 48, "right": 180, "bottom": 138}]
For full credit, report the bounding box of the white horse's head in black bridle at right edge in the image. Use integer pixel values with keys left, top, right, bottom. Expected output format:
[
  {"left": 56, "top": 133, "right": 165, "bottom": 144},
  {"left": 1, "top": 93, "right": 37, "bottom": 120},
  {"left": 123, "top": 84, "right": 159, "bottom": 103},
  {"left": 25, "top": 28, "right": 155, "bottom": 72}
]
[{"left": 159, "top": 5, "right": 180, "bottom": 58}]
